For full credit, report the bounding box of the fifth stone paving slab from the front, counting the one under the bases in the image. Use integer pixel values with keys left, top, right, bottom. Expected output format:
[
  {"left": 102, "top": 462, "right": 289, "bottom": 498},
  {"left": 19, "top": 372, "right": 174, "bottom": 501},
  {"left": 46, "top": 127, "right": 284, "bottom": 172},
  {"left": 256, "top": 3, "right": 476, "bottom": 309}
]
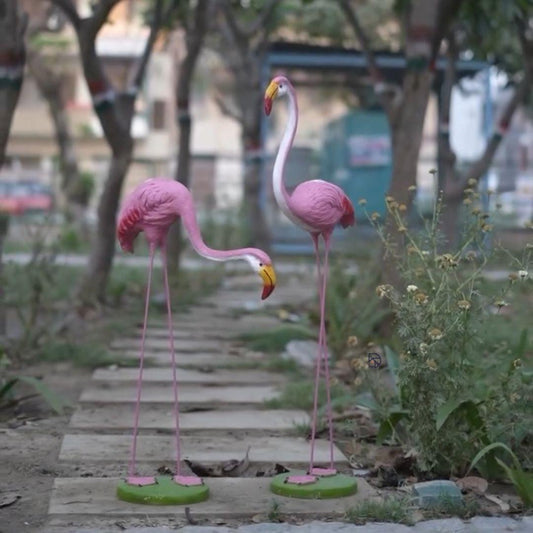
[{"left": 93, "top": 367, "right": 286, "bottom": 385}]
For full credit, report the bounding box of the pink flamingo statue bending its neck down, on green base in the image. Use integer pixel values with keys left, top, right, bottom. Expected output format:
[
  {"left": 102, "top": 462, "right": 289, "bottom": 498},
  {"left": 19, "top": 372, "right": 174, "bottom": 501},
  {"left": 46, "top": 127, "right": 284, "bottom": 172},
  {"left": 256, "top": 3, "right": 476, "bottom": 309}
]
[{"left": 117, "top": 178, "right": 276, "bottom": 504}]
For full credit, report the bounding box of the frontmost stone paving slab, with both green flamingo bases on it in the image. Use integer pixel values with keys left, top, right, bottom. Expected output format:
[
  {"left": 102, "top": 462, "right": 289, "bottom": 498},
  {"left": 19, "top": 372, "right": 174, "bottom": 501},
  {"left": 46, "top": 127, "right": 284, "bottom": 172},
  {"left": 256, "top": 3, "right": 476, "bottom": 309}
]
[{"left": 49, "top": 478, "right": 376, "bottom": 518}]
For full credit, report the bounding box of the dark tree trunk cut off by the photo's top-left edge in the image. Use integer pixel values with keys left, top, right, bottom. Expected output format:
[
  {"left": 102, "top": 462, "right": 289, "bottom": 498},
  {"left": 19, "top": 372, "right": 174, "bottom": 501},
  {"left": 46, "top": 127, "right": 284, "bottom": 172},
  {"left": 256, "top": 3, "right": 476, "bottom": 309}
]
[{"left": 0, "top": 0, "right": 28, "bottom": 168}]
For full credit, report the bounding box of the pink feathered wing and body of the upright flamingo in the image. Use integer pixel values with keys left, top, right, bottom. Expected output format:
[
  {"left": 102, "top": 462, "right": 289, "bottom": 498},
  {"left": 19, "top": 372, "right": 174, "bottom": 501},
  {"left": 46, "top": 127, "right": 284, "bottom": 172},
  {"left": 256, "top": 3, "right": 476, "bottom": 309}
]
[{"left": 290, "top": 180, "right": 355, "bottom": 232}]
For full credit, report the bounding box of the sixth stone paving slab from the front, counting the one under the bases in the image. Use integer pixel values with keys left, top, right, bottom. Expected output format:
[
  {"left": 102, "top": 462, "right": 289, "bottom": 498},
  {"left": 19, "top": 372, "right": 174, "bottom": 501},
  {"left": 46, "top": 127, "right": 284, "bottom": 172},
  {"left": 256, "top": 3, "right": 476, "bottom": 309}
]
[{"left": 111, "top": 350, "right": 261, "bottom": 368}]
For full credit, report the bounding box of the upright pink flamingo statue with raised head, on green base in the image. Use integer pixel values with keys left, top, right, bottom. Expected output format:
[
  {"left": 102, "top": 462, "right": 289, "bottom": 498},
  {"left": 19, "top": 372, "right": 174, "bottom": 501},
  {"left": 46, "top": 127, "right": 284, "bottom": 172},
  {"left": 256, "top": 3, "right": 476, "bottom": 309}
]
[{"left": 264, "top": 76, "right": 357, "bottom": 498}]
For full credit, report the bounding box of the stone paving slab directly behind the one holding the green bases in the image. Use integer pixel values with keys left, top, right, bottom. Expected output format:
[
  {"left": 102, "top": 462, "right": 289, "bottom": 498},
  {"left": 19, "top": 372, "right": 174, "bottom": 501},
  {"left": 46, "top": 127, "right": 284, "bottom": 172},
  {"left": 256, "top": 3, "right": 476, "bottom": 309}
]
[{"left": 59, "top": 434, "right": 348, "bottom": 467}]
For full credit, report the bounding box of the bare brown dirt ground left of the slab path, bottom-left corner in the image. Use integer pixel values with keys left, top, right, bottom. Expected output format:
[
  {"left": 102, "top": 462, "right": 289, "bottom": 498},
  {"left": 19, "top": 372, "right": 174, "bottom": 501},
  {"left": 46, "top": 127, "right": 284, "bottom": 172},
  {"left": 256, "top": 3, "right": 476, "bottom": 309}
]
[{"left": 0, "top": 363, "right": 91, "bottom": 533}]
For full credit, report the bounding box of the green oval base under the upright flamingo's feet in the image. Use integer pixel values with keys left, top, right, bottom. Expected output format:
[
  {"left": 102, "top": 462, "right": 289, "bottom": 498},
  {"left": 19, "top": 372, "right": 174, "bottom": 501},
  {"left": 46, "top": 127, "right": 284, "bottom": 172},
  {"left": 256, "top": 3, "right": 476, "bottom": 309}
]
[{"left": 270, "top": 472, "right": 357, "bottom": 500}]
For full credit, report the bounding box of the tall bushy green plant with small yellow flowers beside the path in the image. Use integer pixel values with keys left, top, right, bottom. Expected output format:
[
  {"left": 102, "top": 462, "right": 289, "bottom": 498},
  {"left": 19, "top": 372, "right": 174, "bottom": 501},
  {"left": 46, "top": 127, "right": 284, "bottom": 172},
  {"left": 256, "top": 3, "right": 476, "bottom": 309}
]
[{"left": 371, "top": 184, "right": 533, "bottom": 476}]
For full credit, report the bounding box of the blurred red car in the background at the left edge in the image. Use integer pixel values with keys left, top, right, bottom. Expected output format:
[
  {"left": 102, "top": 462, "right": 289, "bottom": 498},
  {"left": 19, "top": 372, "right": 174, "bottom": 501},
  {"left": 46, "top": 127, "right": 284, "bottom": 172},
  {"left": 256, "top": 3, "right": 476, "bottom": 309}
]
[{"left": 0, "top": 181, "right": 54, "bottom": 215}]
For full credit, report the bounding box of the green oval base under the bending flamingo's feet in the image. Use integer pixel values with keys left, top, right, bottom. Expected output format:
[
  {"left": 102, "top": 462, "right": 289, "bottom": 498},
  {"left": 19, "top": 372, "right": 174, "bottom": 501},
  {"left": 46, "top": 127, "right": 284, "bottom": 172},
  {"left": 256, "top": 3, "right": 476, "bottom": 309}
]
[{"left": 117, "top": 477, "right": 209, "bottom": 505}]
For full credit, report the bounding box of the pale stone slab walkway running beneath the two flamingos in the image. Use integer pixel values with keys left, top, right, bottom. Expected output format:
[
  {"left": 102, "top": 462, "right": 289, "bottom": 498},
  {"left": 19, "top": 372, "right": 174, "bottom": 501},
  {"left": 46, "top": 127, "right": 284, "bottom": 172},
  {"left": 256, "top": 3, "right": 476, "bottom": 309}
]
[{"left": 45, "top": 277, "right": 533, "bottom": 533}]
